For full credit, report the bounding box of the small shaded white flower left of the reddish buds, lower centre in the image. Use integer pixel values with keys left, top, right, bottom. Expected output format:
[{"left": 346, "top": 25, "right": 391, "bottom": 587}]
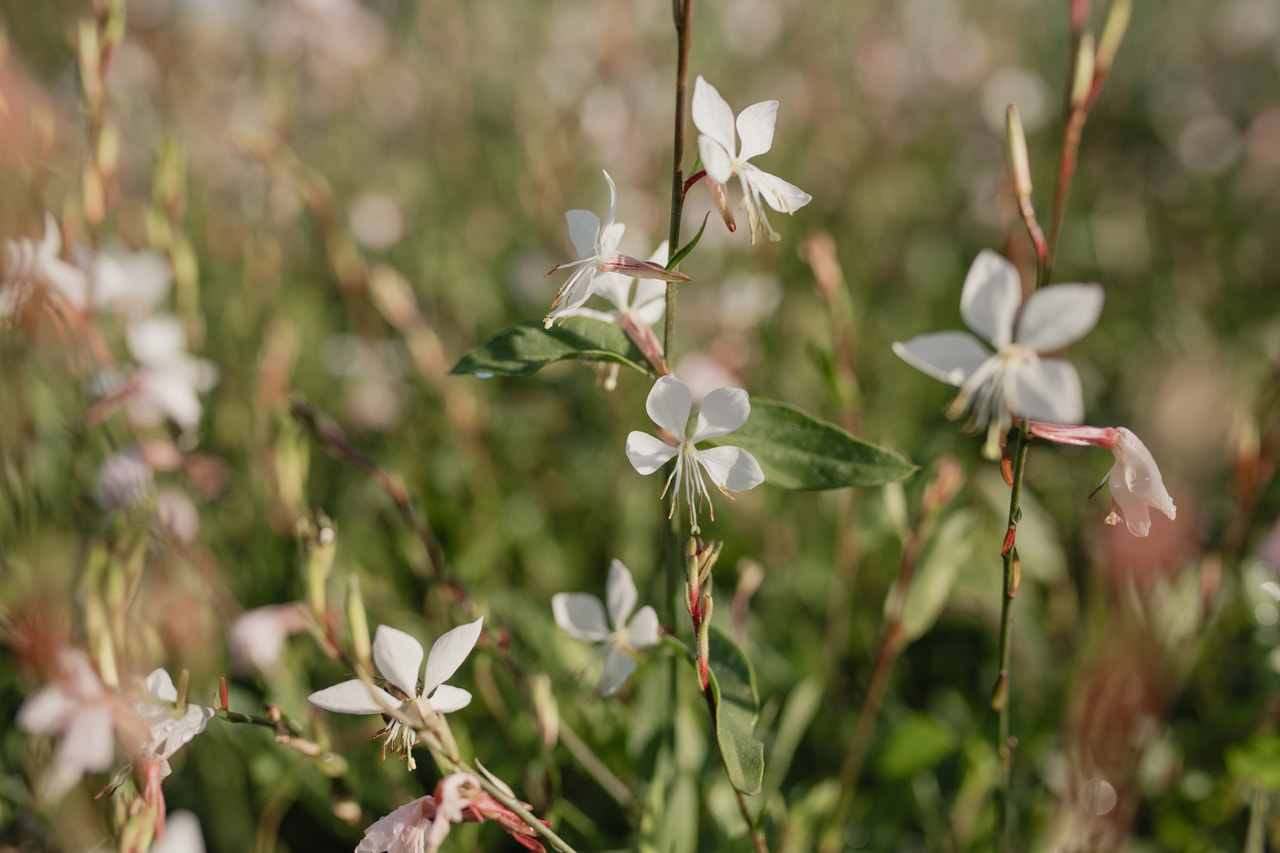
[{"left": 552, "top": 560, "right": 658, "bottom": 695}]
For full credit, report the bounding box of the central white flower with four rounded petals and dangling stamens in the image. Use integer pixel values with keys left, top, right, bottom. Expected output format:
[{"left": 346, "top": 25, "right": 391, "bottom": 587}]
[{"left": 627, "top": 377, "right": 764, "bottom": 533}]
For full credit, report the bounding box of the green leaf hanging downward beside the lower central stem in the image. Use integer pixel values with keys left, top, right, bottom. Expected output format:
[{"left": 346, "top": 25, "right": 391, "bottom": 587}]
[{"left": 709, "top": 628, "right": 764, "bottom": 794}]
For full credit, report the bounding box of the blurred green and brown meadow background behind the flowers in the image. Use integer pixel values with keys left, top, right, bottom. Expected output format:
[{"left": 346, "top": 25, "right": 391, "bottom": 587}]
[{"left": 0, "top": 0, "right": 1280, "bottom": 852}]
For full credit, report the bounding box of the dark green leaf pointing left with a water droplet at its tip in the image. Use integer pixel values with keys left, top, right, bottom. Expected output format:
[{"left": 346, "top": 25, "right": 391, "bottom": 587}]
[{"left": 452, "top": 316, "right": 655, "bottom": 377}]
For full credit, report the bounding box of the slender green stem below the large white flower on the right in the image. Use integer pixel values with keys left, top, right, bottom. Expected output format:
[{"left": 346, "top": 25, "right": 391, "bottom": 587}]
[{"left": 991, "top": 420, "right": 1030, "bottom": 850}]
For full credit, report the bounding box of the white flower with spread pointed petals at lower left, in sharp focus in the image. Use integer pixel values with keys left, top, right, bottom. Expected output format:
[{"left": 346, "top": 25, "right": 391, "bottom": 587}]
[{"left": 307, "top": 616, "right": 484, "bottom": 770}]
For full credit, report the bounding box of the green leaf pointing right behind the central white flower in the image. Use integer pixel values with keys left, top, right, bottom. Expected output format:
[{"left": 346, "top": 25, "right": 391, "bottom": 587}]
[{"left": 707, "top": 398, "right": 915, "bottom": 491}]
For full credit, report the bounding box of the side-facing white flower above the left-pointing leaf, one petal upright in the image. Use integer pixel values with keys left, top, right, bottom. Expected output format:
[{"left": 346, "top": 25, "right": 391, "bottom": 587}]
[{"left": 544, "top": 172, "right": 689, "bottom": 328}]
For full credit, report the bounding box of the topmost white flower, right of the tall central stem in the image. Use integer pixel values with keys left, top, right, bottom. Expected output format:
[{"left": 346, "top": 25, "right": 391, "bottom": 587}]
[{"left": 691, "top": 76, "right": 813, "bottom": 243}]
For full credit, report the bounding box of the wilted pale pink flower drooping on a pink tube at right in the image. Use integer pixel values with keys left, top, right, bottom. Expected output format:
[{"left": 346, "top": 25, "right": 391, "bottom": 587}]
[{"left": 1028, "top": 420, "right": 1178, "bottom": 537}]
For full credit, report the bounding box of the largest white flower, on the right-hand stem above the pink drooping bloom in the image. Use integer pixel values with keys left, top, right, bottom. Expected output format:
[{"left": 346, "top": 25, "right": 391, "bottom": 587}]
[{"left": 893, "top": 250, "right": 1105, "bottom": 459}]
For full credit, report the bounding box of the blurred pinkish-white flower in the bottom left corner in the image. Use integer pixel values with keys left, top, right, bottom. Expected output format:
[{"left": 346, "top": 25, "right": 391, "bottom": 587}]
[{"left": 17, "top": 648, "right": 147, "bottom": 800}]
